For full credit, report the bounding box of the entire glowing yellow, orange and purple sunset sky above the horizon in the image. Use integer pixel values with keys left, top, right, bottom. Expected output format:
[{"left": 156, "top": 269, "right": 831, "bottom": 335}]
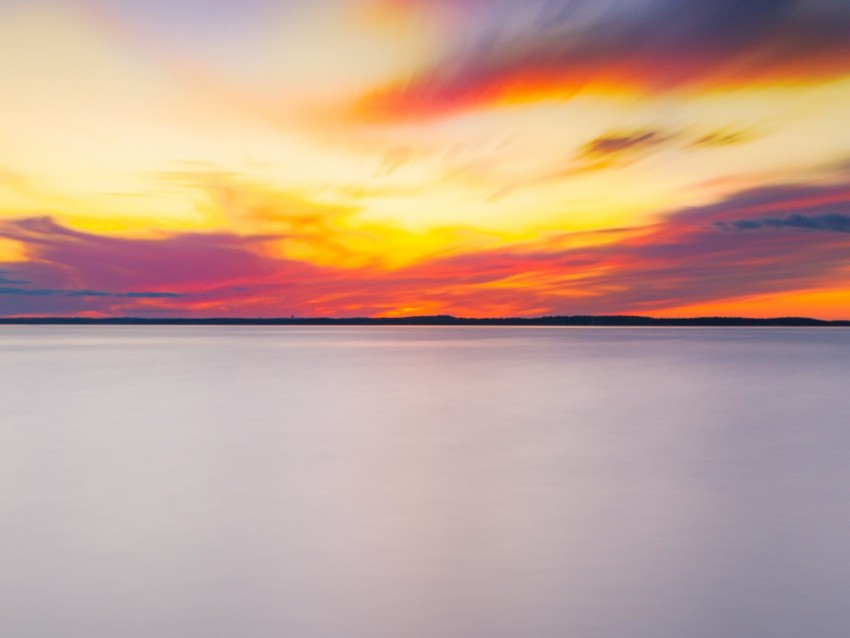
[{"left": 0, "top": 0, "right": 850, "bottom": 319}]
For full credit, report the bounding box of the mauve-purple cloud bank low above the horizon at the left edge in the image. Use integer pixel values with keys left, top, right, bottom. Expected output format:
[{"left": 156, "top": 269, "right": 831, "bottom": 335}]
[{"left": 0, "top": 217, "right": 310, "bottom": 314}]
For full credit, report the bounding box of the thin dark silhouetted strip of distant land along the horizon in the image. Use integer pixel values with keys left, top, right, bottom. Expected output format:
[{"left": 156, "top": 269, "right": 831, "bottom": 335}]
[{"left": 0, "top": 315, "right": 850, "bottom": 328}]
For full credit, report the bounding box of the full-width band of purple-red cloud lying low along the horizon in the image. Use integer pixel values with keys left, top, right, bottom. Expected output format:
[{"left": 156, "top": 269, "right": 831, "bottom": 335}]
[{"left": 0, "top": 178, "right": 850, "bottom": 316}]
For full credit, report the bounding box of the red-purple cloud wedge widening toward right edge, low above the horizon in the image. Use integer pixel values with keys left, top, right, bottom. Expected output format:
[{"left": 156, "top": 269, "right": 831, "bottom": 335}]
[{"left": 388, "top": 180, "right": 850, "bottom": 315}]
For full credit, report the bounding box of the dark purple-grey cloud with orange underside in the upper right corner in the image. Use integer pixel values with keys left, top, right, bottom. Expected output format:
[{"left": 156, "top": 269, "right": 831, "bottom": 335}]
[{"left": 356, "top": 0, "right": 850, "bottom": 119}]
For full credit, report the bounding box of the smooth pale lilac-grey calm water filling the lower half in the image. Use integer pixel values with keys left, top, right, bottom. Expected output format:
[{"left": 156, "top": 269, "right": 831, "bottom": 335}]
[{"left": 0, "top": 327, "right": 850, "bottom": 638}]
